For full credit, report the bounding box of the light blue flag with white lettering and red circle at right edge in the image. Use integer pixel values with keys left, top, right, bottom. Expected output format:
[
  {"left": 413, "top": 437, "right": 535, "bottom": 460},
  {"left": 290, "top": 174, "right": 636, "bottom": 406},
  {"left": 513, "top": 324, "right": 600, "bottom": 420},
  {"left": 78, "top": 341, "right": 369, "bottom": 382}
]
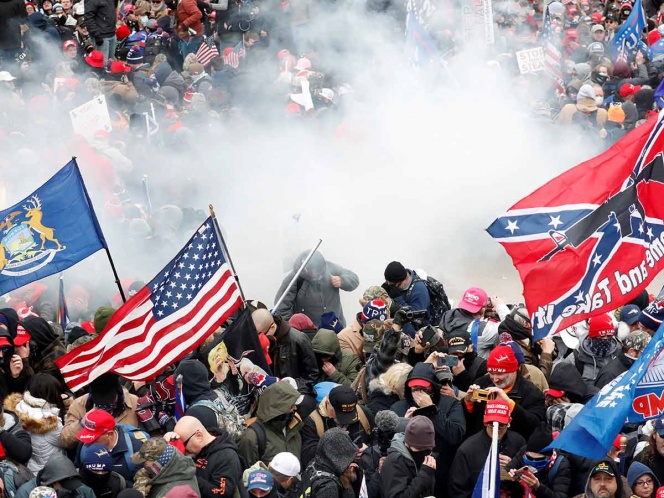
[{"left": 549, "top": 318, "right": 664, "bottom": 459}]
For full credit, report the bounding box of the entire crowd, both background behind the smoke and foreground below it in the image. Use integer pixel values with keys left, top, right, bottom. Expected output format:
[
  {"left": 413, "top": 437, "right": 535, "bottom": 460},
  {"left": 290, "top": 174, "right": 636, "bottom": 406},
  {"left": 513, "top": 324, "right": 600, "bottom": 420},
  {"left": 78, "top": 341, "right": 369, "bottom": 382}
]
[{"left": 0, "top": 0, "right": 664, "bottom": 498}]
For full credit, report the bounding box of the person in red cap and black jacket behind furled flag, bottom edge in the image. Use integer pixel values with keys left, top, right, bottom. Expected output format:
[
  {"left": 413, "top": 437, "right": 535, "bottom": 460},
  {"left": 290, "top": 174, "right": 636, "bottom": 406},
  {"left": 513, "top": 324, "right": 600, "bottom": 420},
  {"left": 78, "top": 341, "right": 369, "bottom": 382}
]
[{"left": 448, "top": 399, "right": 526, "bottom": 498}]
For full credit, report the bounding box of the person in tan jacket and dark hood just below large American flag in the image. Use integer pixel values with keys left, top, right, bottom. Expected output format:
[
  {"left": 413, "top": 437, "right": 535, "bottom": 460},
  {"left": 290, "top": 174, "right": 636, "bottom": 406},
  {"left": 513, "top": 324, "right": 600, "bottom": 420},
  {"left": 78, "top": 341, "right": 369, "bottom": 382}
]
[{"left": 60, "top": 372, "right": 139, "bottom": 449}]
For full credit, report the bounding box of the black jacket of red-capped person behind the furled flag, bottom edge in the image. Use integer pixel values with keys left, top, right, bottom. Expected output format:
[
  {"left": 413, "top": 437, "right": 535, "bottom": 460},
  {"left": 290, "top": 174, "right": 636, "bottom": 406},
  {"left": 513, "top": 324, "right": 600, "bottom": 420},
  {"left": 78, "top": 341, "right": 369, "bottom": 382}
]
[{"left": 449, "top": 430, "right": 526, "bottom": 498}]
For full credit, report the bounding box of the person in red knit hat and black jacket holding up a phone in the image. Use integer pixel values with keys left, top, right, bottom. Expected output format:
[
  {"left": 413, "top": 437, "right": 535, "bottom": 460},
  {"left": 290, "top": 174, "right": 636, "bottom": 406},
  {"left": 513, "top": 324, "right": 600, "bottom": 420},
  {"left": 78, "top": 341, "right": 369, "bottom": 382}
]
[{"left": 464, "top": 345, "right": 546, "bottom": 438}]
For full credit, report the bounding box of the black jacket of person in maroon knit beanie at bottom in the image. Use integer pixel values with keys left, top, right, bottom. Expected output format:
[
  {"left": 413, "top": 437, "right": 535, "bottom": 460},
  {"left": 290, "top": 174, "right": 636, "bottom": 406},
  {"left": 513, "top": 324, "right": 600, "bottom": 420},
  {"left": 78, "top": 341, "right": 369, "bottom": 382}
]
[{"left": 380, "top": 434, "right": 436, "bottom": 498}]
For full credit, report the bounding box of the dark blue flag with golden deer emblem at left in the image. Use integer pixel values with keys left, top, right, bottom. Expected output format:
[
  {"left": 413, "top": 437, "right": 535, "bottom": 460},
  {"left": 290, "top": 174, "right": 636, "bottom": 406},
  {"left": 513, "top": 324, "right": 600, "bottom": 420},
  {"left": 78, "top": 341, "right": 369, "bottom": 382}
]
[{"left": 0, "top": 159, "right": 107, "bottom": 295}]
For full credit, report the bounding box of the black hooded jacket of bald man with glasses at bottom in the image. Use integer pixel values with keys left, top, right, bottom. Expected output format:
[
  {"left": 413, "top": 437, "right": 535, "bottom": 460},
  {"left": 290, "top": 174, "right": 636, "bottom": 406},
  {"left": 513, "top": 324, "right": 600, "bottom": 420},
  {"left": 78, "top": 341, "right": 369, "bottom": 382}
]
[{"left": 194, "top": 430, "right": 244, "bottom": 498}]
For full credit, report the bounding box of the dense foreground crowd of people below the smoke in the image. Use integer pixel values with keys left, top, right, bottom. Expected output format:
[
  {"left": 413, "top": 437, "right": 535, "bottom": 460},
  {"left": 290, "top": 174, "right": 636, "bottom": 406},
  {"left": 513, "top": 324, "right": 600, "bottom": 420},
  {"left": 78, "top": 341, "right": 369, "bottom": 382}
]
[{"left": 0, "top": 252, "right": 664, "bottom": 498}]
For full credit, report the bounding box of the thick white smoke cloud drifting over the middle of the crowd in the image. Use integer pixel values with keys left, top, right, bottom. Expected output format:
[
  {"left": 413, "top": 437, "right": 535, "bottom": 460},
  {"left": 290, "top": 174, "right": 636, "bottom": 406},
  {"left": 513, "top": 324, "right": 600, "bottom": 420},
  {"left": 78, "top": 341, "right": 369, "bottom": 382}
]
[{"left": 6, "top": 6, "right": 652, "bottom": 317}]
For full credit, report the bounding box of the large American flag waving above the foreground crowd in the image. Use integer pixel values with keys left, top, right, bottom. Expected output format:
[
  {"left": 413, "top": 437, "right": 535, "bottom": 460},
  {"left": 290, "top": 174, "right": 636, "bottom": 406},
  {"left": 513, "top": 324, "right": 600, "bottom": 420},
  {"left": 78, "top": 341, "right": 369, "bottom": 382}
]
[{"left": 56, "top": 218, "right": 242, "bottom": 391}]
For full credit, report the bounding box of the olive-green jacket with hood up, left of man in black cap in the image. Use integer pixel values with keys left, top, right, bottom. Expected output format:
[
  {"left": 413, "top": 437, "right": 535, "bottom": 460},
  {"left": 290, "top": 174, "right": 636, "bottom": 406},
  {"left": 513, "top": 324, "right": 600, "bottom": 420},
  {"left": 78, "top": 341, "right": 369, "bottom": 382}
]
[{"left": 236, "top": 381, "right": 304, "bottom": 466}]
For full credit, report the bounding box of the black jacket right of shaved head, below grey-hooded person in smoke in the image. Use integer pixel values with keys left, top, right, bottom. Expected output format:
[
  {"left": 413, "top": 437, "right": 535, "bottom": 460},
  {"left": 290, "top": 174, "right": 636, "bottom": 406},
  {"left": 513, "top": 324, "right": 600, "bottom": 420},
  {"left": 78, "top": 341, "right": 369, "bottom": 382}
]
[{"left": 270, "top": 316, "right": 318, "bottom": 394}]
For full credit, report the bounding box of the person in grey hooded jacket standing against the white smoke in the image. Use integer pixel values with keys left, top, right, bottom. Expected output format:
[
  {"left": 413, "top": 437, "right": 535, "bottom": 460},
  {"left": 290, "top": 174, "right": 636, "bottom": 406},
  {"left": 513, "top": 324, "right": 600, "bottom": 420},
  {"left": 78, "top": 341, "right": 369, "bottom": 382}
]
[{"left": 274, "top": 251, "right": 360, "bottom": 325}]
